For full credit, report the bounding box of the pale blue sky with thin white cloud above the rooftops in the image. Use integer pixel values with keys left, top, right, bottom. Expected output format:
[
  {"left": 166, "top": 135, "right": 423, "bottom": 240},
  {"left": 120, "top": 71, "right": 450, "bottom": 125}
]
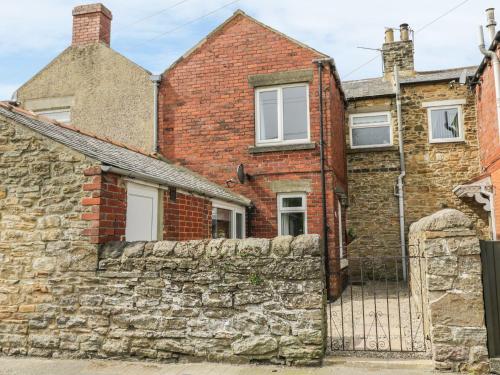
[{"left": 0, "top": 0, "right": 500, "bottom": 99}]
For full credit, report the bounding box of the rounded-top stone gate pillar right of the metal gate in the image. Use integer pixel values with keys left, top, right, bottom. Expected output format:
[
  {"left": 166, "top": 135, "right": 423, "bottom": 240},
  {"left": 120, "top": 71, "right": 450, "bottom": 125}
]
[{"left": 409, "top": 209, "right": 489, "bottom": 374}]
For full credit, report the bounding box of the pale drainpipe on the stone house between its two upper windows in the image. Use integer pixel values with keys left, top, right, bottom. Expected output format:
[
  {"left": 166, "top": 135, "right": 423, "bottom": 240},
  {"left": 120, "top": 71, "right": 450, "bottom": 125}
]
[{"left": 394, "top": 65, "right": 407, "bottom": 281}]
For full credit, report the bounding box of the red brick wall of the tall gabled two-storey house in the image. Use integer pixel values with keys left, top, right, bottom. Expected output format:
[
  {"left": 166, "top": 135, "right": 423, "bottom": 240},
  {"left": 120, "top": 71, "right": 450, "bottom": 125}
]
[{"left": 159, "top": 15, "right": 345, "bottom": 296}]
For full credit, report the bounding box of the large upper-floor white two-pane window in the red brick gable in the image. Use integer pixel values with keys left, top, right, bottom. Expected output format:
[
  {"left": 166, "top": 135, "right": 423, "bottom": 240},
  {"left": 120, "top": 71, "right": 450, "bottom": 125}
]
[{"left": 255, "top": 83, "right": 310, "bottom": 145}]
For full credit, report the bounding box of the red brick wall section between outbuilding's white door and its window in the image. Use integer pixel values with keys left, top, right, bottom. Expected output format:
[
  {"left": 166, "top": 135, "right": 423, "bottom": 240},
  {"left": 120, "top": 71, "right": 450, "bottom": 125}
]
[{"left": 163, "top": 192, "right": 212, "bottom": 241}]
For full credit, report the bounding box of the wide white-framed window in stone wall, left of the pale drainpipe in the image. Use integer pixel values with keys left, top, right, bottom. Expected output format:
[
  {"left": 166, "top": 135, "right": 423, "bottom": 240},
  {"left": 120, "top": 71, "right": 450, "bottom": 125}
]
[{"left": 349, "top": 112, "right": 392, "bottom": 148}]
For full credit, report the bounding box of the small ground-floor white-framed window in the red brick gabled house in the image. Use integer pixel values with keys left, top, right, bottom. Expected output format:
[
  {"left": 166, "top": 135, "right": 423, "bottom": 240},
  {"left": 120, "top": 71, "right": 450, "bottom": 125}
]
[{"left": 278, "top": 193, "right": 307, "bottom": 236}]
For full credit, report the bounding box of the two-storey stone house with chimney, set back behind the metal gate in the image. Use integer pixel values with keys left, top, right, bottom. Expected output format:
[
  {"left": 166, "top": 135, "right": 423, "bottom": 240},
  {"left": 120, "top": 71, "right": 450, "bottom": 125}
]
[{"left": 343, "top": 24, "right": 488, "bottom": 277}]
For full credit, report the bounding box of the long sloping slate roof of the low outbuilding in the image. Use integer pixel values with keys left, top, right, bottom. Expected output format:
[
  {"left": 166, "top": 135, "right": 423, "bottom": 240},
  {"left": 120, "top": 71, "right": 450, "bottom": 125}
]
[{"left": 0, "top": 102, "right": 251, "bottom": 206}]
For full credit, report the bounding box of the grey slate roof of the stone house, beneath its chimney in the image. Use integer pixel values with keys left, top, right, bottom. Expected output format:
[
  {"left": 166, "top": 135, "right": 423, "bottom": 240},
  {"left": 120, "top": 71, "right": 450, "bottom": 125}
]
[{"left": 342, "top": 66, "right": 477, "bottom": 99}]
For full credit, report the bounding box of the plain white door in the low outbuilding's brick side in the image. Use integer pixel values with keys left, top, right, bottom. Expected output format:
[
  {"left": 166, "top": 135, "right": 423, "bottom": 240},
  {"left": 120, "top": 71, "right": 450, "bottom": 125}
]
[{"left": 125, "top": 182, "right": 158, "bottom": 241}]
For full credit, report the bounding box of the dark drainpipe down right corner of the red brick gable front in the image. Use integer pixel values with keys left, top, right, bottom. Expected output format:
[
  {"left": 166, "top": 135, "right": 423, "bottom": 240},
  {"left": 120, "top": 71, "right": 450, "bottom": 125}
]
[{"left": 313, "top": 59, "right": 331, "bottom": 298}]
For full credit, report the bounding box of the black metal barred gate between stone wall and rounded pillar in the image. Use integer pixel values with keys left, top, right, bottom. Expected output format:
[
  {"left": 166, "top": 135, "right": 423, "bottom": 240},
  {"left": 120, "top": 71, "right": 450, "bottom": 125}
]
[{"left": 327, "top": 256, "right": 427, "bottom": 352}]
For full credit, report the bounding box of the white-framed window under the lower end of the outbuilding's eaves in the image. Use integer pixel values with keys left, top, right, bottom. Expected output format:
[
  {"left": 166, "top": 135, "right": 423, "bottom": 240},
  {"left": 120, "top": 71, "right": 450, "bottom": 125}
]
[{"left": 212, "top": 201, "right": 246, "bottom": 238}]
